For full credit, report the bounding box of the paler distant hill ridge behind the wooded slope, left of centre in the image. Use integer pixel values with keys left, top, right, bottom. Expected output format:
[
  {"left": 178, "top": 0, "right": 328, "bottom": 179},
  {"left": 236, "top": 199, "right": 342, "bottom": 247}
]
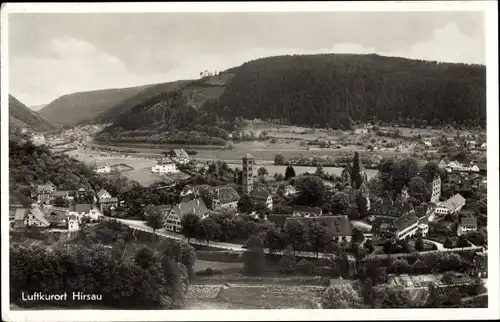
[{"left": 40, "top": 85, "right": 158, "bottom": 126}]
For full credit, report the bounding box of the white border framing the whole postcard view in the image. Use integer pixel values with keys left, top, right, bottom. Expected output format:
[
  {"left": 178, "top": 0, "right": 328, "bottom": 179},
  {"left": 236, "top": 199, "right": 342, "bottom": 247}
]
[{"left": 1, "top": 1, "right": 500, "bottom": 321}]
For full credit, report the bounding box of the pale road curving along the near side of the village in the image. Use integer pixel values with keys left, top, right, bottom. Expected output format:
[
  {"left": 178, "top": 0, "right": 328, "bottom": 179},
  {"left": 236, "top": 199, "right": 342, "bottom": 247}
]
[{"left": 110, "top": 217, "right": 484, "bottom": 261}]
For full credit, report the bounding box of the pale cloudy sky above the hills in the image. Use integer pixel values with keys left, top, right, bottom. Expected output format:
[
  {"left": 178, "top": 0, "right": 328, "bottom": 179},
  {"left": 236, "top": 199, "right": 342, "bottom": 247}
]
[{"left": 9, "top": 11, "right": 486, "bottom": 106}]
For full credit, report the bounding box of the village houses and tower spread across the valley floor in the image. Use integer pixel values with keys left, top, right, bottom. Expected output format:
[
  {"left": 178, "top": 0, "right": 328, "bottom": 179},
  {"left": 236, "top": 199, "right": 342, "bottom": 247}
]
[{"left": 12, "top": 125, "right": 487, "bottom": 304}]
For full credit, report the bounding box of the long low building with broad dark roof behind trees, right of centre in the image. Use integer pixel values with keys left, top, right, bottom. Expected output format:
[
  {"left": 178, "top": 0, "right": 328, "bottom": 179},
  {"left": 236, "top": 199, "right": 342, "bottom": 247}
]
[{"left": 285, "top": 216, "right": 354, "bottom": 242}]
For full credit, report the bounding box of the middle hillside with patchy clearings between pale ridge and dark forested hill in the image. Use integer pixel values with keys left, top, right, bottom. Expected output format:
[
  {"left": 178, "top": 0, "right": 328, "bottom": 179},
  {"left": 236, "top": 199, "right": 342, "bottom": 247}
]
[{"left": 96, "top": 73, "right": 239, "bottom": 145}]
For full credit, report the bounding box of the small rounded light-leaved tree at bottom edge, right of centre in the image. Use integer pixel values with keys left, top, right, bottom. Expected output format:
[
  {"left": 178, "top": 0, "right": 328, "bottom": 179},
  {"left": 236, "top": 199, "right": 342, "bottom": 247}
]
[{"left": 322, "top": 283, "right": 362, "bottom": 309}]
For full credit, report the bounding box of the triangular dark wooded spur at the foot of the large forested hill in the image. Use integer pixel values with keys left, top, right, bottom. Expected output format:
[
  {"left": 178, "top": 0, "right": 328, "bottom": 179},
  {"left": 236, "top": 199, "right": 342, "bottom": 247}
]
[{"left": 96, "top": 90, "right": 242, "bottom": 146}]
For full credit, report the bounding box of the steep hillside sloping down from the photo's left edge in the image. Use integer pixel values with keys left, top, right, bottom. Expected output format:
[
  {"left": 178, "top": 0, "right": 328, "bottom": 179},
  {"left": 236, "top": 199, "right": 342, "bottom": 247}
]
[{"left": 9, "top": 95, "right": 55, "bottom": 132}]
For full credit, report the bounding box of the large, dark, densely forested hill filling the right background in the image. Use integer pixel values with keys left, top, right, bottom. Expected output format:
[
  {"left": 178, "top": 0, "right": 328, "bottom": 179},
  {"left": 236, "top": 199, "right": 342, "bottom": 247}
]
[{"left": 206, "top": 54, "right": 486, "bottom": 128}]
